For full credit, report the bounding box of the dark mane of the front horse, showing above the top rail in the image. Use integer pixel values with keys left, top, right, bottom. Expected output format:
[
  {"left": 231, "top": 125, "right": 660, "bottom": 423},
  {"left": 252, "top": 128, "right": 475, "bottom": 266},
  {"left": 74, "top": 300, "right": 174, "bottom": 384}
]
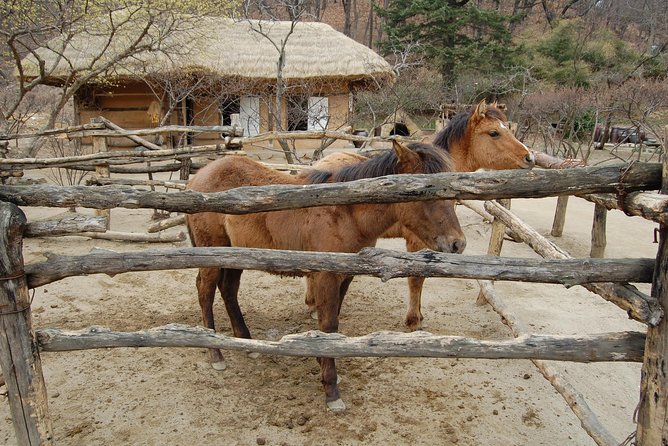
[{"left": 305, "top": 143, "right": 453, "bottom": 184}]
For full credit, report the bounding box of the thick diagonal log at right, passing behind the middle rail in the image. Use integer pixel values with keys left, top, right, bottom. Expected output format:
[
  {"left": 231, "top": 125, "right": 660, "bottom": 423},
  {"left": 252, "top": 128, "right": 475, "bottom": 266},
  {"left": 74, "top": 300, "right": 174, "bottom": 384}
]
[{"left": 485, "top": 202, "right": 664, "bottom": 326}]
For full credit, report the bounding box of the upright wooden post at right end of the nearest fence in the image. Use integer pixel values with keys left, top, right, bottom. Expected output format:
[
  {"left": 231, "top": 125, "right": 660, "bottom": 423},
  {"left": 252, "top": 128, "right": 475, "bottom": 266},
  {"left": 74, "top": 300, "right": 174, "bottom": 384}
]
[{"left": 636, "top": 144, "right": 668, "bottom": 446}]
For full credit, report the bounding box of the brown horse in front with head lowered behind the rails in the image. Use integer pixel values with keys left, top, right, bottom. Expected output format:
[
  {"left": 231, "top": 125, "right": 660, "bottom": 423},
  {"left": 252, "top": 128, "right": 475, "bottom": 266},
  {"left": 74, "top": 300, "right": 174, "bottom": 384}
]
[{"left": 186, "top": 142, "right": 465, "bottom": 411}]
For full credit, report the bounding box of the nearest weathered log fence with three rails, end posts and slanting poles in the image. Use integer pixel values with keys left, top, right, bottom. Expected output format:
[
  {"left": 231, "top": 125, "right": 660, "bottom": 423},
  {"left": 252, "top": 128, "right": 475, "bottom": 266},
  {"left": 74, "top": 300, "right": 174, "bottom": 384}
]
[{"left": 0, "top": 121, "right": 668, "bottom": 446}]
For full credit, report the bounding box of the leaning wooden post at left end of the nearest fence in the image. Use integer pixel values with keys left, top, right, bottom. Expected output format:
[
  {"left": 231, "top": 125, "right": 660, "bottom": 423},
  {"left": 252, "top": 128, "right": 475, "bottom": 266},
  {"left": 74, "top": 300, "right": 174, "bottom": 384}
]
[{"left": 0, "top": 202, "right": 53, "bottom": 445}]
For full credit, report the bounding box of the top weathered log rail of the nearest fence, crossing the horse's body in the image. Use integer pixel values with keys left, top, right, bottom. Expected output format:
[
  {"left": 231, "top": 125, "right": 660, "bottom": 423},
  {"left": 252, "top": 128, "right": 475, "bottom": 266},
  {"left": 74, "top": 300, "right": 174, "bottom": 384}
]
[{"left": 0, "top": 163, "right": 661, "bottom": 214}]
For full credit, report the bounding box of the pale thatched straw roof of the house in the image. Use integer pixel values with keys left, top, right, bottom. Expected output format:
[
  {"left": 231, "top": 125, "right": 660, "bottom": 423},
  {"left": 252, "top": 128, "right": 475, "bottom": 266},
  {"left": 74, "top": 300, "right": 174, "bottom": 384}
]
[{"left": 24, "top": 17, "right": 394, "bottom": 88}]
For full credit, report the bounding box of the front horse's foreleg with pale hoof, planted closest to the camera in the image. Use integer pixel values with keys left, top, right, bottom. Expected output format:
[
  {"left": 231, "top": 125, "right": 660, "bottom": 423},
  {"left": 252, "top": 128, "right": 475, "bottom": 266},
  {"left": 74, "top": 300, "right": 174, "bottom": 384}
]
[{"left": 312, "top": 273, "right": 346, "bottom": 412}]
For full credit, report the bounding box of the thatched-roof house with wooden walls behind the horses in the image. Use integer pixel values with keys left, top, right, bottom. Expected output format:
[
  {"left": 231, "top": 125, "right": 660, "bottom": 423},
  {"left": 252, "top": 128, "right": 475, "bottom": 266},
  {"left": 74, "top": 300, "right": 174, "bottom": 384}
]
[{"left": 24, "top": 17, "right": 394, "bottom": 148}]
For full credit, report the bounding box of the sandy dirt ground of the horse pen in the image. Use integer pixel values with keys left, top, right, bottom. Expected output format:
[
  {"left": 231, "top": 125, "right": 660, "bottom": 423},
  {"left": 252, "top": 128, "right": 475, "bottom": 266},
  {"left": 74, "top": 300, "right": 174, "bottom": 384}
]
[{"left": 0, "top": 145, "right": 657, "bottom": 446}]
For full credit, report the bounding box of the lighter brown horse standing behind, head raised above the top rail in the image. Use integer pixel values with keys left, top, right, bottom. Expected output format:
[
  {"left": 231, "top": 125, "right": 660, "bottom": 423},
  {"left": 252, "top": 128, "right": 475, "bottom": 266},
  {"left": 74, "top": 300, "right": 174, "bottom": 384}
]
[{"left": 305, "top": 100, "right": 535, "bottom": 331}]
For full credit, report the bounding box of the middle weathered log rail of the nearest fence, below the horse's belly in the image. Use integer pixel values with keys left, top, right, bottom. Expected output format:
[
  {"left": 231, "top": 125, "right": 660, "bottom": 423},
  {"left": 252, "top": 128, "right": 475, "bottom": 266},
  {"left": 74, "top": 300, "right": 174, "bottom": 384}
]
[{"left": 26, "top": 247, "right": 654, "bottom": 287}]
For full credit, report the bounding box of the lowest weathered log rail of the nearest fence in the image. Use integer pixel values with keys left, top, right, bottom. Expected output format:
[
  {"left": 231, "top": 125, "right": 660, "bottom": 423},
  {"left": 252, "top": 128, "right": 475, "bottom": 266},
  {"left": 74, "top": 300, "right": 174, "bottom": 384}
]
[{"left": 37, "top": 324, "right": 645, "bottom": 362}]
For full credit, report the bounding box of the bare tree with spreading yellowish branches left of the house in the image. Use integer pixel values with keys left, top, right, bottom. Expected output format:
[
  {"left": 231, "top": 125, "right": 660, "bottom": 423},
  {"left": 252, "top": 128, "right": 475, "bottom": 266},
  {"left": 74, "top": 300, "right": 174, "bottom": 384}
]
[{"left": 0, "top": 0, "right": 232, "bottom": 156}]
